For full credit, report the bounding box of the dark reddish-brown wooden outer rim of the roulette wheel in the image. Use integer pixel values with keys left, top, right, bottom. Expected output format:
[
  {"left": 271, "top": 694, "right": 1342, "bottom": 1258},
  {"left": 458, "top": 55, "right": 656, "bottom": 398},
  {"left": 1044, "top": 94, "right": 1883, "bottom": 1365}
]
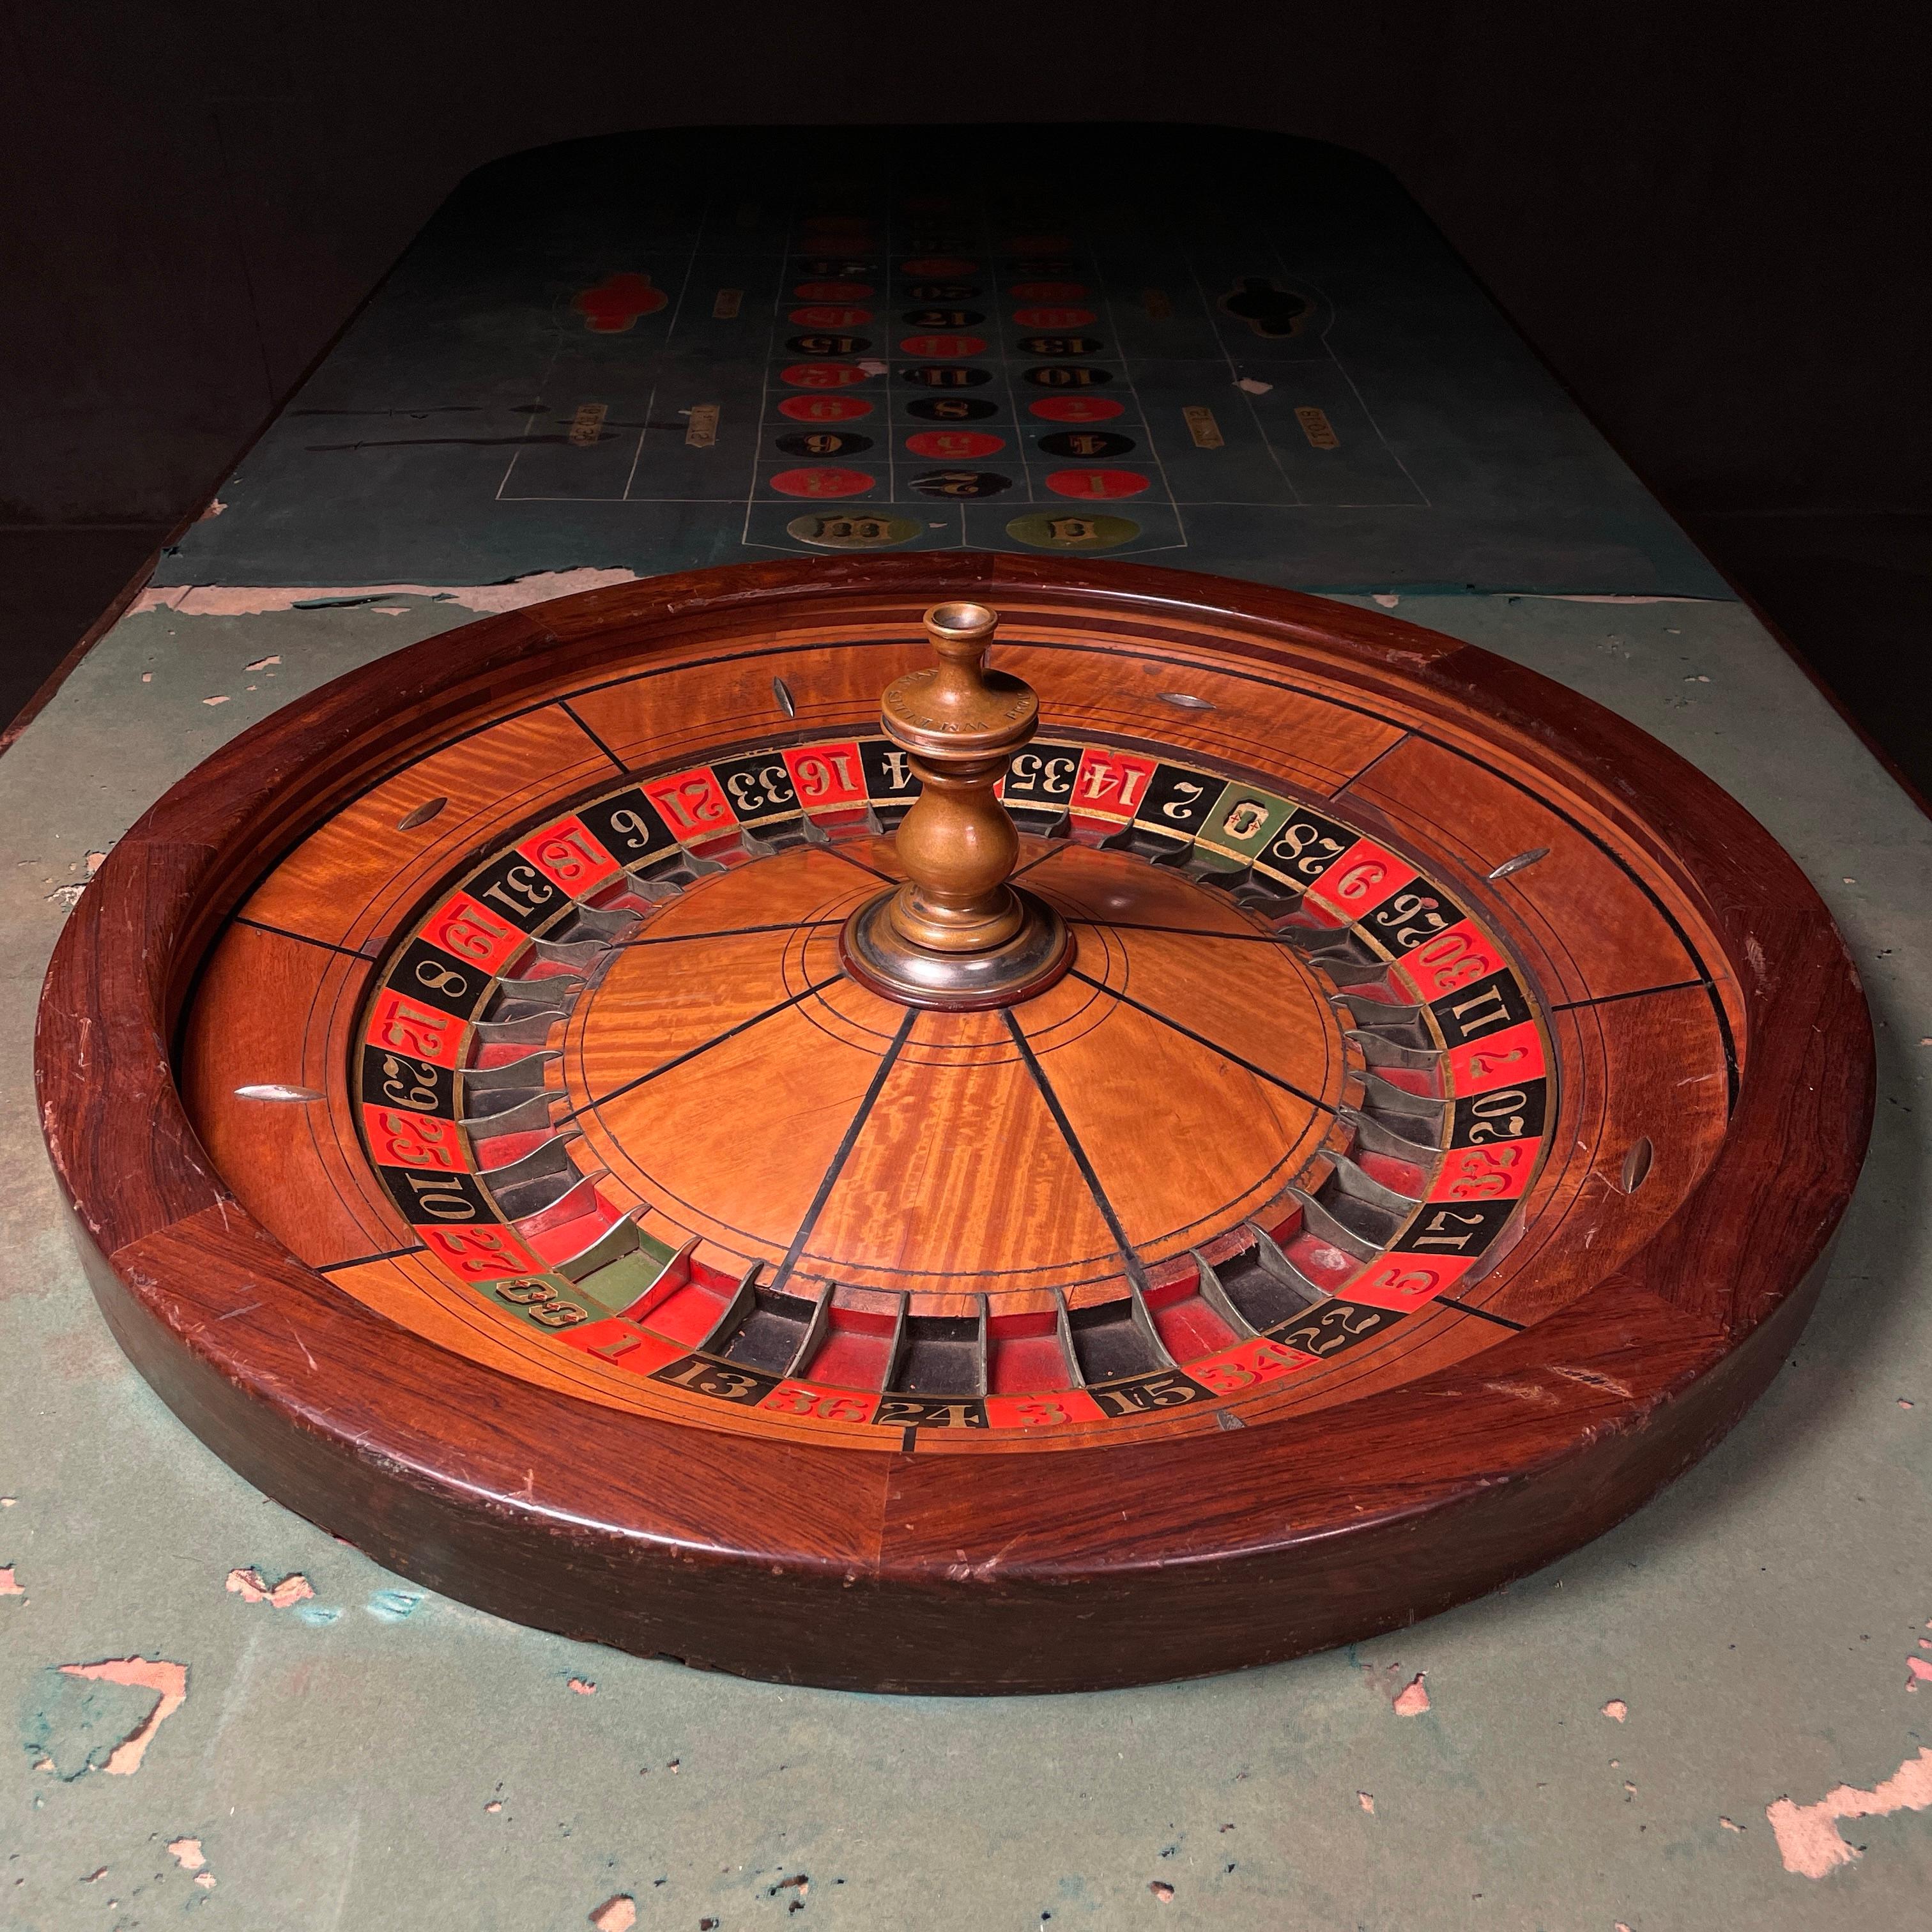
[{"left": 36, "top": 555, "right": 1874, "bottom": 1690}]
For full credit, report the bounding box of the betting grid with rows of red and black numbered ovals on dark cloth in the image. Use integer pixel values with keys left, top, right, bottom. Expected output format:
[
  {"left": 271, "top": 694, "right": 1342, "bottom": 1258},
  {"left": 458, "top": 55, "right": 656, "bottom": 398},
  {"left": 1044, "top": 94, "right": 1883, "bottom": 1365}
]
[{"left": 496, "top": 182, "right": 1426, "bottom": 555}]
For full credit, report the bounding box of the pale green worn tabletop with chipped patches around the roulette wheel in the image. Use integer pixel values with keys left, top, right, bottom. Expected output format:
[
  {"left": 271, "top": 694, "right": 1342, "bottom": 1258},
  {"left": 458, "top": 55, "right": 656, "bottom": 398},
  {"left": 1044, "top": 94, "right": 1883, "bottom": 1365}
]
[{"left": 0, "top": 597, "right": 1932, "bottom": 1932}]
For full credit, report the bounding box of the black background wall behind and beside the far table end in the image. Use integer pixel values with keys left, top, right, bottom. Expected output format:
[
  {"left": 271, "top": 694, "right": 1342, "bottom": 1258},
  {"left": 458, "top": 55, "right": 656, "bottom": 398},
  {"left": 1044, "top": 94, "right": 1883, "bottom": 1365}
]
[{"left": 0, "top": 0, "right": 1932, "bottom": 776}]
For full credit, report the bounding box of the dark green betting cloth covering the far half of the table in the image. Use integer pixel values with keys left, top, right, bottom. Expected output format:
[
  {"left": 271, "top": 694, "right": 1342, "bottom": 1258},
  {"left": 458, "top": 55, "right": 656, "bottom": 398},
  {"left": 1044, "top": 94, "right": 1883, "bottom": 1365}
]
[{"left": 142, "top": 128, "right": 1729, "bottom": 597}]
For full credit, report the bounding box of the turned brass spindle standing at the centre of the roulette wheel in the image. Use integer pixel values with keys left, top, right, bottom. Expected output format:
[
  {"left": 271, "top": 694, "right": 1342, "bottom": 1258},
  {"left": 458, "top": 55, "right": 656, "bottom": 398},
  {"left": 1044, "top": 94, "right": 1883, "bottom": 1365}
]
[{"left": 838, "top": 602, "right": 1072, "bottom": 1009}]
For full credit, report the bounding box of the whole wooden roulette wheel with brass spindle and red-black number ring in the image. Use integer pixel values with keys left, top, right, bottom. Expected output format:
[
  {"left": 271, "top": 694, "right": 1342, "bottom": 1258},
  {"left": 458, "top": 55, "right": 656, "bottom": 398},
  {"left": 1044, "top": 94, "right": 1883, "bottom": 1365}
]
[{"left": 36, "top": 552, "right": 1872, "bottom": 1692}]
